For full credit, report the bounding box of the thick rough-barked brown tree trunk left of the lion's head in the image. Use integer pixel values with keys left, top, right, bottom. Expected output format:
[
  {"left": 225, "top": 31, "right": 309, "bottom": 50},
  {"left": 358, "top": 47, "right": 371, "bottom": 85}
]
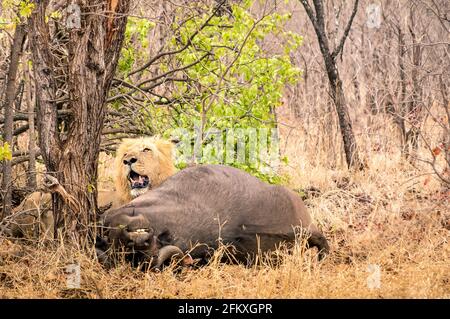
[{"left": 30, "top": 0, "right": 130, "bottom": 238}]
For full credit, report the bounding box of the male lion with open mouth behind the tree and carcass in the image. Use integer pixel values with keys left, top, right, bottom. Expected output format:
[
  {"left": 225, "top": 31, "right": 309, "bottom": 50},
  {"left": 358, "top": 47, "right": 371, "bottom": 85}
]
[{"left": 0, "top": 137, "right": 175, "bottom": 239}]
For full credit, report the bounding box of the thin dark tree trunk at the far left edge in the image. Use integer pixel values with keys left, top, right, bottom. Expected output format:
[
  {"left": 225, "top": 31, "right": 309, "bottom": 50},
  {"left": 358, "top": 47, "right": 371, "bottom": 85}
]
[{"left": 2, "top": 23, "right": 26, "bottom": 216}]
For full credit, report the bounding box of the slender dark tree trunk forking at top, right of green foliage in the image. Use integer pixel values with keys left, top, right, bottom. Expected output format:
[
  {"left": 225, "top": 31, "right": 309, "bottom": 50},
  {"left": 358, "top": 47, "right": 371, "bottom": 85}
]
[{"left": 300, "top": 0, "right": 366, "bottom": 170}]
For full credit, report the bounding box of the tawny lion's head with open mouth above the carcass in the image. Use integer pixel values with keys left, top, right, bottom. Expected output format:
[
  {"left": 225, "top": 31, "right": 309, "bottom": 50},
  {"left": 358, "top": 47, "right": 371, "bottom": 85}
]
[{"left": 115, "top": 137, "right": 175, "bottom": 203}]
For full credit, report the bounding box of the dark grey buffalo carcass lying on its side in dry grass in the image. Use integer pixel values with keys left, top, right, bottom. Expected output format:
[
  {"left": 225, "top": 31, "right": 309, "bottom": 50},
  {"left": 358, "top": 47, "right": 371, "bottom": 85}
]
[{"left": 103, "top": 165, "right": 329, "bottom": 267}]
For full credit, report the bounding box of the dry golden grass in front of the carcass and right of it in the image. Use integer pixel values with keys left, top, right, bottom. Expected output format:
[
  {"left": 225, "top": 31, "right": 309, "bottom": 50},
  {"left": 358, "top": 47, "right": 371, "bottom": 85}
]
[{"left": 0, "top": 110, "right": 450, "bottom": 298}]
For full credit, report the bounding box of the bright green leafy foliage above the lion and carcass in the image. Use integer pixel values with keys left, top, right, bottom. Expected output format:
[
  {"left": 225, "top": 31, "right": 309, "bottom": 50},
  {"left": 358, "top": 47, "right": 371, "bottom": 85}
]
[{"left": 117, "top": 0, "right": 303, "bottom": 184}]
